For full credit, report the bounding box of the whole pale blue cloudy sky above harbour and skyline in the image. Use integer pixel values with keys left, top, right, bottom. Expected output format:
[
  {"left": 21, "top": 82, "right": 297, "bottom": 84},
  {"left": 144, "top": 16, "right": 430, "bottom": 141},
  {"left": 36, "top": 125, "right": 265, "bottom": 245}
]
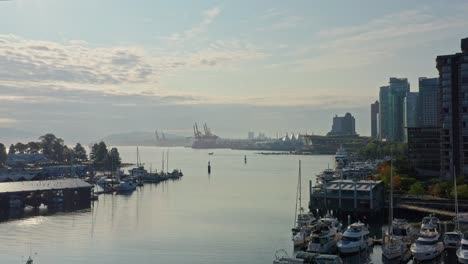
[{"left": 0, "top": 0, "right": 468, "bottom": 142}]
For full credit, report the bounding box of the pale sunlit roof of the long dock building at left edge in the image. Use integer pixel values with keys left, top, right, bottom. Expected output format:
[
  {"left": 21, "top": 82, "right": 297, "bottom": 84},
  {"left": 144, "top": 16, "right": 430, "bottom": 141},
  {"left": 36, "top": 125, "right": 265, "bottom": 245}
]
[{"left": 0, "top": 178, "right": 93, "bottom": 194}]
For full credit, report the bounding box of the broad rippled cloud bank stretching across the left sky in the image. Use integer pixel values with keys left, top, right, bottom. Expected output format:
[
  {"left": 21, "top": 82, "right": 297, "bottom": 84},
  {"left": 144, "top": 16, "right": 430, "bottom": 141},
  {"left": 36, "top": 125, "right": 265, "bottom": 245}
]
[{"left": 0, "top": 34, "right": 265, "bottom": 93}]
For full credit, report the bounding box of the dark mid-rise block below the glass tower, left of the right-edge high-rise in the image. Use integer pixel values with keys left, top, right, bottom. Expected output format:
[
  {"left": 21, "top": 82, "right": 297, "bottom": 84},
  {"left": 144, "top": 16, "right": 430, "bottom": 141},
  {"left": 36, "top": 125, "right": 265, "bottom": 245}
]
[{"left": 407, "top": 127, "right": 440, "bottom": 178}]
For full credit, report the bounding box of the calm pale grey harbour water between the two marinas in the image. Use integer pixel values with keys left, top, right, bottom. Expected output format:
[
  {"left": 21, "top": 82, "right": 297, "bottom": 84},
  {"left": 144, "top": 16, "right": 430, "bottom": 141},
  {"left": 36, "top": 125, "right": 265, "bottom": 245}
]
[{"left": 0, "top": 147, "right": 458, "bottom": 264}]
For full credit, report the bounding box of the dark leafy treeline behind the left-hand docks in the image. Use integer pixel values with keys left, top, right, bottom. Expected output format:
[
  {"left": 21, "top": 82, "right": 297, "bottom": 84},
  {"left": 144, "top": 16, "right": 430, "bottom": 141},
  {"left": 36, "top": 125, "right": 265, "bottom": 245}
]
[{"left": 0, "top": 133, "right": 121, "bottom": 170}]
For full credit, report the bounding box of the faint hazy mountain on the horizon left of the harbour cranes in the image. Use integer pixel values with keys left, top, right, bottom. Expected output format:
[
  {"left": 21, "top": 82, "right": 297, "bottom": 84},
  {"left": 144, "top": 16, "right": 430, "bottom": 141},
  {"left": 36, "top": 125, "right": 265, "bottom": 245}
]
[{"left": 101, "top": 131, "right": 192, "bottom": 147}]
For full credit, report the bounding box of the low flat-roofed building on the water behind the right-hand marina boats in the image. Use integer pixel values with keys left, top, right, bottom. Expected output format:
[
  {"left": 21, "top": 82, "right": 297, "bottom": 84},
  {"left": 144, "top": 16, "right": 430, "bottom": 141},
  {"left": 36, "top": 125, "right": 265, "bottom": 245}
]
[{"left": 309, "top": 180, "right": 385, "bottom": 213}]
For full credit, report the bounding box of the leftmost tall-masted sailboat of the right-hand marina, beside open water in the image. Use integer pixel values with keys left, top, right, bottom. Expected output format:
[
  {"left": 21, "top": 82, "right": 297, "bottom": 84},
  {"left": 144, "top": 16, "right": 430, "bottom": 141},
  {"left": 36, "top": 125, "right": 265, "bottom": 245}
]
[{"left": 292, "top": 160, "right": 316, "bottom": 247}]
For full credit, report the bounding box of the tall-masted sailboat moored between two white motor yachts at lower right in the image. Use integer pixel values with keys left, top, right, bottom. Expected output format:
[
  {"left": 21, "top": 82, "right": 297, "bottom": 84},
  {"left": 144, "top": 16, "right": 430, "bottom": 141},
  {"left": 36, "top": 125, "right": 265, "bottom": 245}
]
[{"left": 382, "top": 154, "right": 406, "bottom": 259}]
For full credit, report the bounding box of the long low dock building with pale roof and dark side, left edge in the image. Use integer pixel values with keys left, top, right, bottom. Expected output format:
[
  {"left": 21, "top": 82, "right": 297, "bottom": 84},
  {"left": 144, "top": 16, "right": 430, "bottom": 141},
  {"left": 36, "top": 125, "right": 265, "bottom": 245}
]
[{"left": 0, "top": 178, "right": 93, "bottom": 210}]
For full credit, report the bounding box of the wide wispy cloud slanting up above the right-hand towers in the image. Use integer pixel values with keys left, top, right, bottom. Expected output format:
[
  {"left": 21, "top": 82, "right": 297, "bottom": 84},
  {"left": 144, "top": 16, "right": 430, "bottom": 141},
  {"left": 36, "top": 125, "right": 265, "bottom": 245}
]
[{"left": 289, "top": 9, "right": 468, "bottom": 71}]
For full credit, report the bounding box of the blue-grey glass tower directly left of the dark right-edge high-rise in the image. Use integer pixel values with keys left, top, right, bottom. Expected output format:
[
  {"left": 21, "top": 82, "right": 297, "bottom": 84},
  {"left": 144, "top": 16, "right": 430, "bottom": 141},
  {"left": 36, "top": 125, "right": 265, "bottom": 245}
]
[{"left": 418, "top": 77, "right": 440, "bottom": 127}]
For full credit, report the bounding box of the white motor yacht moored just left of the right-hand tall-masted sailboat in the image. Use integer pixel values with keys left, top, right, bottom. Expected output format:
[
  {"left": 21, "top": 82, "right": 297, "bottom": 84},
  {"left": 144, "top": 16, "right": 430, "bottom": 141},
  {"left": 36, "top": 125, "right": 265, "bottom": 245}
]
[{"left": 337, "top": 222, "right": 372, "bottom": 254}]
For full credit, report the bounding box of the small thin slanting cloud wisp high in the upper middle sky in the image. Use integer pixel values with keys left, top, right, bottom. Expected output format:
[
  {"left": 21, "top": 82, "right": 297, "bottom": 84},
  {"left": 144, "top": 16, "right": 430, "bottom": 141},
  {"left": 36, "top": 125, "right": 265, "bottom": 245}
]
[{"left": 167, "top": 7, "right": 221, "bottom": 44}]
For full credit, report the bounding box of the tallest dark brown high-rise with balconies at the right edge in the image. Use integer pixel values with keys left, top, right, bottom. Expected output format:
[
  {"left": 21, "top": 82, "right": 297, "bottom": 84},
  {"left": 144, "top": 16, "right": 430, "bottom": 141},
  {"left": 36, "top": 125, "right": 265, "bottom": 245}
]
[{"left": 436, "top": 38, "right": 468, "bottom": 181}]
